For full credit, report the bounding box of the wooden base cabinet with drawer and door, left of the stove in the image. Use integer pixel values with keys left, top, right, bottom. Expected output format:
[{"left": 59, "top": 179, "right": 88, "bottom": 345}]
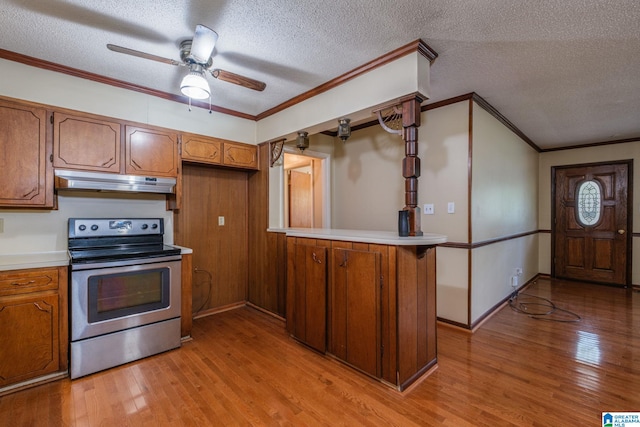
[{"left": 0, "top": 267, "right": 68, "bottom": 392}]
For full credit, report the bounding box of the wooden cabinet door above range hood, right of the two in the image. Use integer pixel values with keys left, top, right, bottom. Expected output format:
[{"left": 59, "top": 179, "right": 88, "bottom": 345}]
[{"left": 125, "top": 126, "right": 178, "bottom": 177}]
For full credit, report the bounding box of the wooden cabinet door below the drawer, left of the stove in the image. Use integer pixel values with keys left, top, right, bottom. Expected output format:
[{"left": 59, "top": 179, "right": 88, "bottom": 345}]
[{"left": 0, "top": 294, "right": 59, "bottom": 387}]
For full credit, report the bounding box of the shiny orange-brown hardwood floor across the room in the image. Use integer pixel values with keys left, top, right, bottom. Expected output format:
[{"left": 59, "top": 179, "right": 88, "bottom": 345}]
[{"left": 0, "top": 279, "right": 640, "bottom": 426}]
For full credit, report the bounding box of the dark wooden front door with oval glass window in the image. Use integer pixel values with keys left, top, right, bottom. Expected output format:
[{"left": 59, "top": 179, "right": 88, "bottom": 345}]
[{"left": 552, "top": 161, "right": 633, "bottom": 286}]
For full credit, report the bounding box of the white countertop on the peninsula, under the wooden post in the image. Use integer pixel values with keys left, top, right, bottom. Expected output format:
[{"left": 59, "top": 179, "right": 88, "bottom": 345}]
[{"left": 267, "top": 228, "right": 447, "bottom": 246}]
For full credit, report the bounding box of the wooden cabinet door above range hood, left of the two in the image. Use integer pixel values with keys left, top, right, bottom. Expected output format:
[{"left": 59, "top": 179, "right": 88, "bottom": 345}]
[{"left": 53, "top": 113, "right": 122, "bottom": 173}]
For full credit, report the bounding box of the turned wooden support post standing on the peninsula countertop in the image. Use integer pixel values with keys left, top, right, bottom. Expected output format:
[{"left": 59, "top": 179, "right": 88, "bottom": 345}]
[{"left": 402, "top": 95, "right": 423, "bottom": 236}]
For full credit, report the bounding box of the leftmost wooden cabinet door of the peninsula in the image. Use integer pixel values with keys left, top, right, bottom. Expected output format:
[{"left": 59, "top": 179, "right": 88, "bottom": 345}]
[{"left": 287, "top": 244, "right": 327, "bottom": 353}]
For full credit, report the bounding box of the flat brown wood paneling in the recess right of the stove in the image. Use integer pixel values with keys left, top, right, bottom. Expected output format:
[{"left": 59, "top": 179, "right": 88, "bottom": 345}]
[{"left": 174, "top": 164, "right": 249, "bottom": 312}]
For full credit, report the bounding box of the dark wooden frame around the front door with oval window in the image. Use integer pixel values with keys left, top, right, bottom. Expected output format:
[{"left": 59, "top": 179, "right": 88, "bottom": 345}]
[{"left": 551, "top": 159, "right": 634, "bottom": 288}]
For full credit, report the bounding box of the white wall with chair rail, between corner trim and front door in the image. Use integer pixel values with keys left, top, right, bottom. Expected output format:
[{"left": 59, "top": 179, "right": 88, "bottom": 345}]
[{"left": 470, "top": 103, "right": 539, "bottom": 324}]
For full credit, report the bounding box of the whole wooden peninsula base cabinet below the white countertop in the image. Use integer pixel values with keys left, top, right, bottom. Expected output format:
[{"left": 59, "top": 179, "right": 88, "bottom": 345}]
[{"left": 287, "top": 236, "right": 437, "bottom": 391}]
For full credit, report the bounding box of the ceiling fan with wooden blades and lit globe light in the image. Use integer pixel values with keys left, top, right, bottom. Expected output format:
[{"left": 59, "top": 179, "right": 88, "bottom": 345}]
[{"left": 107, "top": 25, "right": 267, "bottom": 99}]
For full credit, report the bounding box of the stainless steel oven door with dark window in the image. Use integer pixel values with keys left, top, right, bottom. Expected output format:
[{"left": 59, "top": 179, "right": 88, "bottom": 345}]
[{"left": 70, "top": 256, "right": 181, "bottom": 341}]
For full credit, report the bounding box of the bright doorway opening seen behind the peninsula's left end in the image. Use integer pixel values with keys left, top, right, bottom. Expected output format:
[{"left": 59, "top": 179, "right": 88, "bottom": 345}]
[{"left": 282, "top": 150, "right": 331, "bottom": 228}]
